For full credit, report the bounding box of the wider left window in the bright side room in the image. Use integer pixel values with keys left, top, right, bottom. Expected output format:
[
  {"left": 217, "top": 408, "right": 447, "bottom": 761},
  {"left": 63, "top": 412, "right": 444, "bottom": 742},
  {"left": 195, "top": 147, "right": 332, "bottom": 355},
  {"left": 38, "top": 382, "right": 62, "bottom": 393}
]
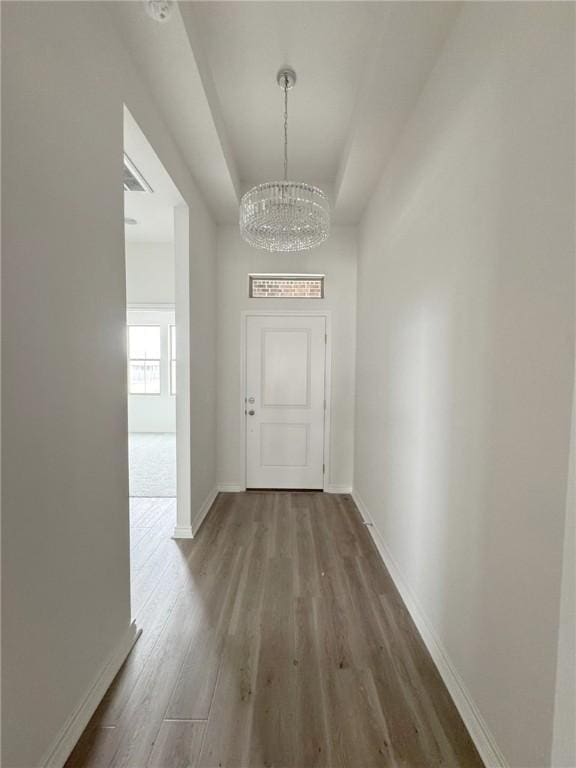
[{"left": 128, "top": 325, "right": 161, "bottom": 395}]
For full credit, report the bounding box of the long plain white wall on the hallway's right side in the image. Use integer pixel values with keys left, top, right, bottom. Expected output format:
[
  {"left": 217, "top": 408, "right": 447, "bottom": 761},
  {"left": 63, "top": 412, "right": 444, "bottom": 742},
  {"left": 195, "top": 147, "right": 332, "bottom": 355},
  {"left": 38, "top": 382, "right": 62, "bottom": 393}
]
[{"left": 355, "top": 3, "right": 574, "bottom": 768}]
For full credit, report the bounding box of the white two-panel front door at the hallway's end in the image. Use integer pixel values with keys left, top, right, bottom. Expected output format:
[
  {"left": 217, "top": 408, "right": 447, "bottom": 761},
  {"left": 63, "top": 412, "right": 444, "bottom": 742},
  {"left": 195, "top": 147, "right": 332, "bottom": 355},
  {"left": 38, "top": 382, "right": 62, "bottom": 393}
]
[{"left": 246, "top": 315, "right": 326, "bottom": 489}]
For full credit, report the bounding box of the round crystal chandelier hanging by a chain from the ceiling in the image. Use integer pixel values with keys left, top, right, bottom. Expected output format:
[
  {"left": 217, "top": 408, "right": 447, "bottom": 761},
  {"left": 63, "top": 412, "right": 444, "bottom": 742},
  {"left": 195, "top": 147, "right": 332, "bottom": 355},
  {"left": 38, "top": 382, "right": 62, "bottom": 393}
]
[{"left": 240, "top": 69, "right": 330, "bottom": 251}]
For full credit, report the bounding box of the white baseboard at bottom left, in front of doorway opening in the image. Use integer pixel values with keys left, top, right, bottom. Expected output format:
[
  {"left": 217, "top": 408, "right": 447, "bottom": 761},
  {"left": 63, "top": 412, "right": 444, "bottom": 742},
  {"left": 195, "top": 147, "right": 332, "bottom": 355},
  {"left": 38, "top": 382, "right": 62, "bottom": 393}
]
[{"left": 40, "top": 622, "right": 142, "bottom": 768}]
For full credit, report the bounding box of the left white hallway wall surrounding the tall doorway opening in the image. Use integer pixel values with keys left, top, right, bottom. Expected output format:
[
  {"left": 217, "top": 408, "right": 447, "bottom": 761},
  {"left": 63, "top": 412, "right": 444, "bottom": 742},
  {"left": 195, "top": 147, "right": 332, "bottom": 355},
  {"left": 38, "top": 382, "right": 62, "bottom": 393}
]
[{"left": 1, "top": 2, "right": 216, "bottom": 768}]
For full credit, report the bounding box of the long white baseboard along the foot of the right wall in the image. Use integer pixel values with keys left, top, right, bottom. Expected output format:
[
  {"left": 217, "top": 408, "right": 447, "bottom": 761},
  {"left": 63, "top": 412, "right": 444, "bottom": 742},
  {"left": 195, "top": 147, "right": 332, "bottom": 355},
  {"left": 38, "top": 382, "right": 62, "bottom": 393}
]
[{"left": 352, "top": 490, "right": 509, "bottom": 768}]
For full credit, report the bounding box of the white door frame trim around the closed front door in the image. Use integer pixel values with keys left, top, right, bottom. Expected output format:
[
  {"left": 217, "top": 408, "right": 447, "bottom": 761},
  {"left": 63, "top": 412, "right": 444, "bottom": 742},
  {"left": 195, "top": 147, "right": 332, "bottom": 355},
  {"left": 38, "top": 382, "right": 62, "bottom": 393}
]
[{"left": 240, "top": 309, "right": 332, "bottom": 491}]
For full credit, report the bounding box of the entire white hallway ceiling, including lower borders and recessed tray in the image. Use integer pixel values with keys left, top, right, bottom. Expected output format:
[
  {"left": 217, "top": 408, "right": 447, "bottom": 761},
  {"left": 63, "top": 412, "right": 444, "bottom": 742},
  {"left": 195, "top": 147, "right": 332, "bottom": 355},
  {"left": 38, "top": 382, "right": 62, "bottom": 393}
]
[{"left": 111, "top": 0, "right": 459, "bottom": 222}]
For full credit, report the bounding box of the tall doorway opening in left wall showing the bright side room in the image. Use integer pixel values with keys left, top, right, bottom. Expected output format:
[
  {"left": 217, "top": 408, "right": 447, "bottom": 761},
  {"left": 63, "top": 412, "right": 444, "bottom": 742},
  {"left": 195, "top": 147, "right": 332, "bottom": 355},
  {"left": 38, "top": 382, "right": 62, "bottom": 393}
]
[{"left": 124, "top": 108, "right": 190, "bottom": 620}]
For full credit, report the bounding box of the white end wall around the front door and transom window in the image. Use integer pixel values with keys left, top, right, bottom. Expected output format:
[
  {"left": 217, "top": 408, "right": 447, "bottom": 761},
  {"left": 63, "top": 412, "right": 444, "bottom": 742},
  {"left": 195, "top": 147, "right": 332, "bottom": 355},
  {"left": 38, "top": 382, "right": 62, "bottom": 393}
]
[{"left": 217, "top": 226, "right": 356, "bottom": 489}]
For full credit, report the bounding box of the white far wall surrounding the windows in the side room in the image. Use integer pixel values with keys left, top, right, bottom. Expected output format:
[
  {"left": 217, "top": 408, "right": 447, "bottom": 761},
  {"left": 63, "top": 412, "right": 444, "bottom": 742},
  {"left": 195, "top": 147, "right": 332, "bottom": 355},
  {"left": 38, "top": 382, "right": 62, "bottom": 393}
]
[{"left": 126, "top": 242, "right": 176, "bottom": 432}]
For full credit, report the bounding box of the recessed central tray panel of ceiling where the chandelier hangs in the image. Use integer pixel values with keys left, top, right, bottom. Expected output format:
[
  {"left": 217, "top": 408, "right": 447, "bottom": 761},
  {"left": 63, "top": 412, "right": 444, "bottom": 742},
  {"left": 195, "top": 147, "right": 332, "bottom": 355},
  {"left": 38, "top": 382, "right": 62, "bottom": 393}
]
[{"left": 187, "top": 2, "right": 380, "bottom": 185}]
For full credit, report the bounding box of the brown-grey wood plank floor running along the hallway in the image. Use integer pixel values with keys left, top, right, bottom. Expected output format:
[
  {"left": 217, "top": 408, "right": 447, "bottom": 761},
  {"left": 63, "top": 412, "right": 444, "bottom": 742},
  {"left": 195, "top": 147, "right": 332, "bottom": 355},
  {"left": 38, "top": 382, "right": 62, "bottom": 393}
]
[{"left": 67, "top": 492, "right": 482, "bottom": 768}]
